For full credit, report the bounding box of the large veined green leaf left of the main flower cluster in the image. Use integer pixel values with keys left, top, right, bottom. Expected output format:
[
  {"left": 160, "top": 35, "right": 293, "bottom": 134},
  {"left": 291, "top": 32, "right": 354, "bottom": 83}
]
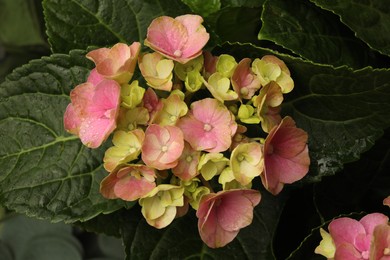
[{"left": 0, "top": 51, "right": 129, "bottom": 222}]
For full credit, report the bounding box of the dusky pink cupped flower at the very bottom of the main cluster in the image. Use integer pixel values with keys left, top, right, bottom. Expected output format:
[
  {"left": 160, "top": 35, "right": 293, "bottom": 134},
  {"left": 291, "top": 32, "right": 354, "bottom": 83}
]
[{"left": 196, "top": 189, "right": 261, "bottom": 248}]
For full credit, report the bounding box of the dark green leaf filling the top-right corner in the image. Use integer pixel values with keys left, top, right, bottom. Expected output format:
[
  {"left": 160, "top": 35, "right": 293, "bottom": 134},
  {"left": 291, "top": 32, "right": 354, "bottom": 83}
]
[{"left": 310, "top": 0, "right": 390, "bottom": 56}]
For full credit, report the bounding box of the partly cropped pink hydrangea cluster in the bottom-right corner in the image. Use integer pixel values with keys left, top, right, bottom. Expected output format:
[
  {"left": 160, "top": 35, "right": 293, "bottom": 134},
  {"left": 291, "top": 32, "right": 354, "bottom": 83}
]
[{"left": 315, "top": 213, "right": 390, "bottom": 260}]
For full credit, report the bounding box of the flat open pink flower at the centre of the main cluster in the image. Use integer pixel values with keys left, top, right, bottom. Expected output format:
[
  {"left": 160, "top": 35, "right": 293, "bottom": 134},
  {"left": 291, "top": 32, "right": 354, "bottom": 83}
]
[{"left": 177, "top": 98, "right": 237, "bottom": 153}]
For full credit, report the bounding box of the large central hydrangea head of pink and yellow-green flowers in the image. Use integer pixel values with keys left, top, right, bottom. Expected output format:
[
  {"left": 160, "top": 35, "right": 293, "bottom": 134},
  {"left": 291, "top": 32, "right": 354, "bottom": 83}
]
[{"left": 64, "top": 15, "right": 310, "bottom": 248}]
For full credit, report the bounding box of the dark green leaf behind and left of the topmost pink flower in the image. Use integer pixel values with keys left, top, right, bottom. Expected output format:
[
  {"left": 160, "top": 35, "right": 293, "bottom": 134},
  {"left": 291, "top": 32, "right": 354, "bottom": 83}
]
[{"left": 43, "top": 0, "right": 189, "bottom": 53}]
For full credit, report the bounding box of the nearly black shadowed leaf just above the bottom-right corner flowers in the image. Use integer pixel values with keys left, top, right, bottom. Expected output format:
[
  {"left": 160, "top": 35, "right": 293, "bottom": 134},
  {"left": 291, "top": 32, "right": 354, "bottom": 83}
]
[{"left": 314, "top": 128, "right": 390, "bottom": 220}]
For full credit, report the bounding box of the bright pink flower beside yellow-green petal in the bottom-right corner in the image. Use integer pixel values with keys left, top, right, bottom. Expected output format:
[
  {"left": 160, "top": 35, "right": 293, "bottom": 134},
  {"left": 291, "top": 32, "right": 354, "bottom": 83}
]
[{"left": 328, "top": 213, "right": 389, "bottom": 260}]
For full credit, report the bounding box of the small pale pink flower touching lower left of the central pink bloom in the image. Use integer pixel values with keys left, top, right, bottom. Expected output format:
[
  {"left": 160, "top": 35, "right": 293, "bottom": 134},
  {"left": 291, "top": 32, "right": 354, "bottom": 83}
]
[{"left": 141, "top": 124, "right": 184, "bottom": 170}]
